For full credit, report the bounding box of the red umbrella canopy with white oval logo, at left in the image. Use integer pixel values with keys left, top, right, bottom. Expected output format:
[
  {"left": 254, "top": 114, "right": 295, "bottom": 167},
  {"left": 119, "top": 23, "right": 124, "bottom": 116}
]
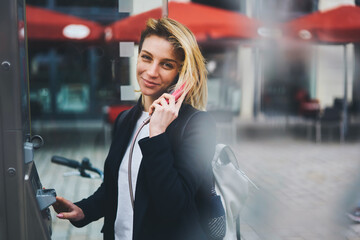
[{"left": 26, "top": 6, "right": 104, "bottom": 41}]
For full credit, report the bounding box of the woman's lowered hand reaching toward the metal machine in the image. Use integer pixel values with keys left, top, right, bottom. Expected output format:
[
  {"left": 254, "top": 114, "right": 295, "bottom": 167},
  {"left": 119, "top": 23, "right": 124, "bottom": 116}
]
[{"left": 52, "top": 197, "right": 85, "bottom": 222}]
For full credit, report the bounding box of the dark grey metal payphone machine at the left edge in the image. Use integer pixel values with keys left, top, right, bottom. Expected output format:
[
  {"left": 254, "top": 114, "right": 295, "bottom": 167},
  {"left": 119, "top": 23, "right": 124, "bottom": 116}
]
[{"left": 0, "top": 0, "right": 55, "bottom": 240}]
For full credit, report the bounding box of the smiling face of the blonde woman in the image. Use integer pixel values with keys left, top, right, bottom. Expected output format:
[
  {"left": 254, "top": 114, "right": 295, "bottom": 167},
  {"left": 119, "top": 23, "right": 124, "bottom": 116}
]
[{"left": 136, "top": 35, "right": 180, "bottom": 101}]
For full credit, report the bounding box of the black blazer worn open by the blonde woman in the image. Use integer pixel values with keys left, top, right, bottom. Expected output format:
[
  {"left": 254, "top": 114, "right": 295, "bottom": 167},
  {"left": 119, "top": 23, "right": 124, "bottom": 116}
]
[{"left": 72, "top": 98, "right": 216, "bottom": 240}]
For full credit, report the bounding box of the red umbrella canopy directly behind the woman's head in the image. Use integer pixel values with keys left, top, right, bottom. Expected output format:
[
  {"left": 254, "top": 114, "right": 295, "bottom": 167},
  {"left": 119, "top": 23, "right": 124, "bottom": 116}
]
[{"left": 105, "top": 2, "right": 258, "bottom": 42}]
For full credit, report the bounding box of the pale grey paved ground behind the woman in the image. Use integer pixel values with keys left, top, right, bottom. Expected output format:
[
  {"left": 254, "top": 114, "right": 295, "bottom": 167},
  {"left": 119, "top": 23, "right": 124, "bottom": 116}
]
[{"left": 35, "top": 120, "right": 360, "bottom": 240}]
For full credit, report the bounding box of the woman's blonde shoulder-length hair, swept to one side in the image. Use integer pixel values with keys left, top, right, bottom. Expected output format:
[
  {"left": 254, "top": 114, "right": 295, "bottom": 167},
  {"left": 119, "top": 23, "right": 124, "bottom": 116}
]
[{"left": 139, "top": 17, "right": 207, "bottom": 110}]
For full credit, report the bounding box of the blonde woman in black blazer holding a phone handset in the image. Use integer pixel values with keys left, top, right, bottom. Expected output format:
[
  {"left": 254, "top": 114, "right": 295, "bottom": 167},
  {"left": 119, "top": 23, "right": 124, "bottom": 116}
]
[{"left": 54, "top": 18, "right": 215, "bottom": 240}]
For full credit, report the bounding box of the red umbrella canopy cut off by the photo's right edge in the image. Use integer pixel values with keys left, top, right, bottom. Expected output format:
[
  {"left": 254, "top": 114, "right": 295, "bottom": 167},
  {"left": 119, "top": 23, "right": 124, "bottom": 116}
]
[{"left": 285, "top": 6, "right": 360, "bottom": 43}]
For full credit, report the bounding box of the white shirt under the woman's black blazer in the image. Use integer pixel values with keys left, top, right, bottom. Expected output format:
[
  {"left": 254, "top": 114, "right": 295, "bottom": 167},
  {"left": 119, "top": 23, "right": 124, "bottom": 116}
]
[{"left": 114, "top": 112, "right": 149, "bottom": 240}]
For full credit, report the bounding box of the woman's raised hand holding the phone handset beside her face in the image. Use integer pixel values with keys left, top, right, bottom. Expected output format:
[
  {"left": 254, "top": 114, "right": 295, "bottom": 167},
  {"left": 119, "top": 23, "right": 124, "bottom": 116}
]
[{"left": 149, "top": 93, "right": 186, "bottom": 137}]
